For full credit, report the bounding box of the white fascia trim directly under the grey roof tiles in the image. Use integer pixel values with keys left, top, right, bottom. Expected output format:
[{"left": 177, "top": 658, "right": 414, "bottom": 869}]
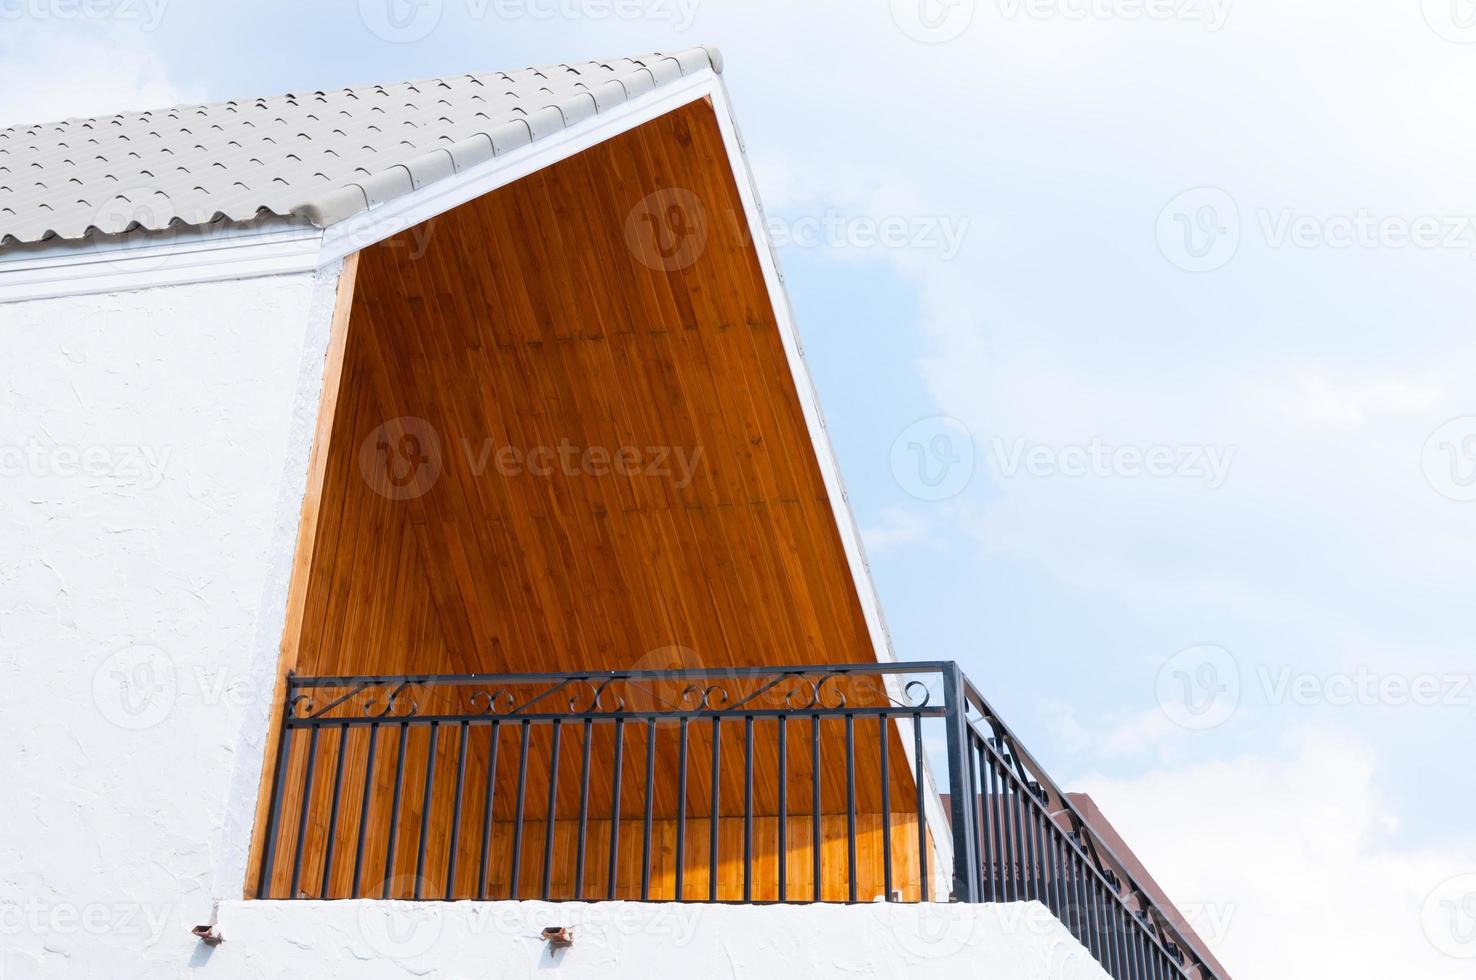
[{"left": 0, "top": 68, "right": 717, "bottom": 303}]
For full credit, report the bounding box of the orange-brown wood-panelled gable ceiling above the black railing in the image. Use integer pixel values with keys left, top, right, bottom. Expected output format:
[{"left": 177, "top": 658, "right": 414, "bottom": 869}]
[{"left": 289, "top": 102, "right": 874, "bottom": 674}]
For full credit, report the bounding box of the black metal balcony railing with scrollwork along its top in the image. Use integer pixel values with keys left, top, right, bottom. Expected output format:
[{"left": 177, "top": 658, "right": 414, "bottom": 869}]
[{"left": 255, "top": 663, "right": 1219, "bottom": 980}]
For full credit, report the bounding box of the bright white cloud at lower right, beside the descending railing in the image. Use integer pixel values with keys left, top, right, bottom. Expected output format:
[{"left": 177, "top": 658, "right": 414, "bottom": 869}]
[{"left": 1073, "top": 728, "right": 1476, "bottom": 980}]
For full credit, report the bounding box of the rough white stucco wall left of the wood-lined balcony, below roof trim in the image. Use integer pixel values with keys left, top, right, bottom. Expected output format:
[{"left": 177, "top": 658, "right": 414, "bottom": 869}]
[{"left": 0, "top": 269, "right": 338, "bottom": 980}]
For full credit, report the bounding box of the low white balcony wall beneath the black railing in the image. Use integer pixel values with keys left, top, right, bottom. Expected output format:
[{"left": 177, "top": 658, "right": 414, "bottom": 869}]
[{"left": 205, "top": 902, "right": 1107, "bottom": 980}]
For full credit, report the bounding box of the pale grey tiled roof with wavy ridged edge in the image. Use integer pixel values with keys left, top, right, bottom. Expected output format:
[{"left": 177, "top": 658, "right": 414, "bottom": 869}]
[{"left": 0, "top": 47, "right": 722, "bottom": 245}]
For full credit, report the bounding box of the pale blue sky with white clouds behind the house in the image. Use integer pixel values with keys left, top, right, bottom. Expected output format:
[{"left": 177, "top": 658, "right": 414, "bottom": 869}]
[{"left": 0, "top": 0, "right": 1476, "bottom": 977}]
